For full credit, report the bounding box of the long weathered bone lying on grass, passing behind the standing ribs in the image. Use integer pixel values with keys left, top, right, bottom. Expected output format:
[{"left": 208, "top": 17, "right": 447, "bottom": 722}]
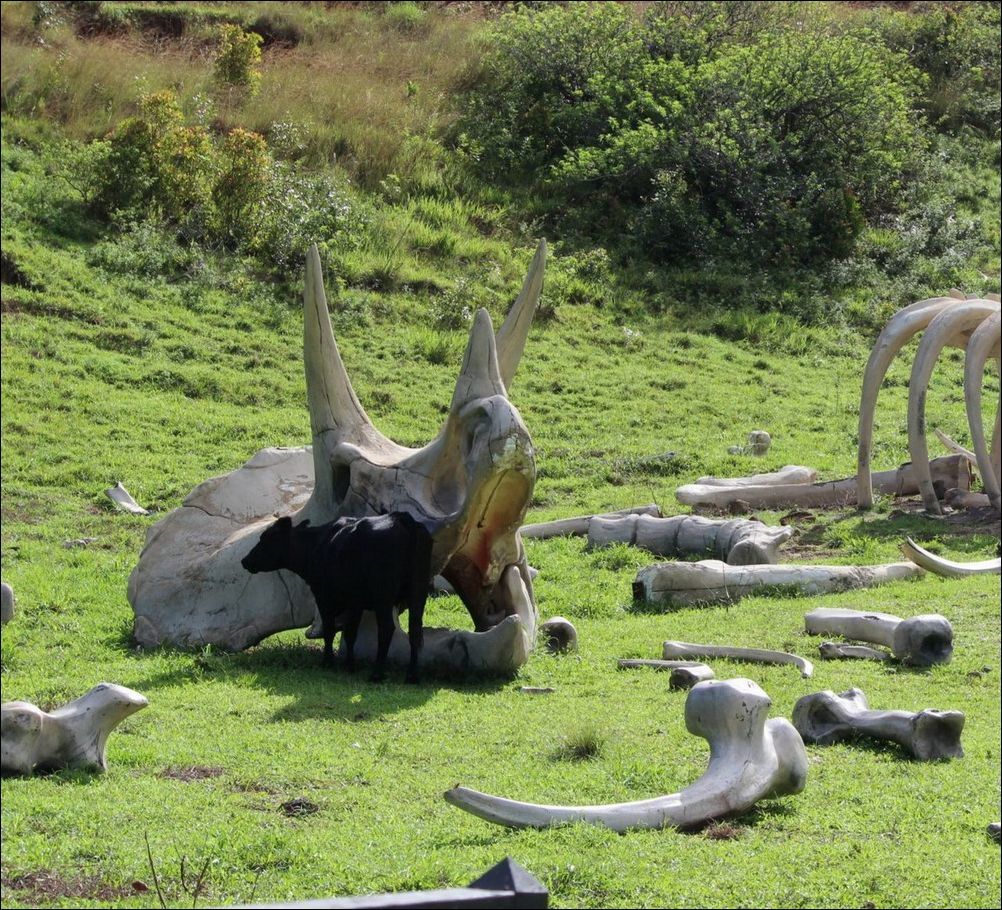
[{"left": 675, "top": 455, "right": 971, "bottom": 509}]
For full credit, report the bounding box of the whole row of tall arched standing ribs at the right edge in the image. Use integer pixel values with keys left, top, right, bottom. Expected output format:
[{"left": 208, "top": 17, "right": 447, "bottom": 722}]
[{"left": 856, "top": 294, "right": 1002, "bottom": 514}]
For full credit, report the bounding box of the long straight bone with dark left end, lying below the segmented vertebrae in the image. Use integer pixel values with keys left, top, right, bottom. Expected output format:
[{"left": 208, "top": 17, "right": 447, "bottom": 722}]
[{"left": 633, "top": 559, "right": 923, "bottom": 606}]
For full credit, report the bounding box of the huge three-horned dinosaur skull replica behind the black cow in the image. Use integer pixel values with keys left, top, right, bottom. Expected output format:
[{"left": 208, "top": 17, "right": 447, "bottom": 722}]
[{"left": 128, "top": 244, "right": 546, "bottom": 672}]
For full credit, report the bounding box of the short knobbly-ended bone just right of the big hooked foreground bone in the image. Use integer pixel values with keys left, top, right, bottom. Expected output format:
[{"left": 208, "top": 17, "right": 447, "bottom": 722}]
[{"left": 794, "top": 689, "right": 964, "bottom": 762}]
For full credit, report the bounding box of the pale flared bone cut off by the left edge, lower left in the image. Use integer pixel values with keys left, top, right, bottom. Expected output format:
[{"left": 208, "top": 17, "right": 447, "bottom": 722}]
[{"left": 0, "top": 683, "right": 149, "bottom": 775}]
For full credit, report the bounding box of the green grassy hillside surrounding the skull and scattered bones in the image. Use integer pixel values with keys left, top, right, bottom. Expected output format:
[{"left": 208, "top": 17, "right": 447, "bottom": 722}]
[{"left": 0, "top": 3, "right": 1002, "bottom": 907}]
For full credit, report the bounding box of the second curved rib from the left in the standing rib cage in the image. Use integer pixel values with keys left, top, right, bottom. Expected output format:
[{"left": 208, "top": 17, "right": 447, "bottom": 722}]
[{"left": 908, "top": 300, "right": 999, "bottom": 515}]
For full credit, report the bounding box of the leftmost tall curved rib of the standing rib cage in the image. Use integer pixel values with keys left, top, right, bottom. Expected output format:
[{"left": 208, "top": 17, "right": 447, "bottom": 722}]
[{"left": 856, "top": 302, "right": 963, "bottom": 509}]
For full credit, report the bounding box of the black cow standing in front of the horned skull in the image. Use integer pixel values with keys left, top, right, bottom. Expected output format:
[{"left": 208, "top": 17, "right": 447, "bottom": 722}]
[{"left": 240, "top": 512, "right": 432, "bottom": 683}]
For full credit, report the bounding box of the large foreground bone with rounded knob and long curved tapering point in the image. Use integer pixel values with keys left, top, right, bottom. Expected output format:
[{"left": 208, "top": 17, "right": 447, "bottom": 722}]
[{"left": 445, "top": 679, "right": 808, "bottom": 831}]
